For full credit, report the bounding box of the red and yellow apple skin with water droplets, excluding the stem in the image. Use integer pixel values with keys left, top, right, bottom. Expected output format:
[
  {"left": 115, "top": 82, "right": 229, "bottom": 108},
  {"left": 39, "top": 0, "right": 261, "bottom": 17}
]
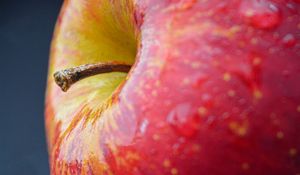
[{"left": 45, "top": 0, "right": 300, "bottom": 175}]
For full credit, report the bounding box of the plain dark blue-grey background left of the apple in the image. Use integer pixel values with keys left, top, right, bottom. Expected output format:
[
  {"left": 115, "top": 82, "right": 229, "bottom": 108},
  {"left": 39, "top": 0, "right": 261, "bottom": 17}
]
[{"left": 0, "top": 0, "right": 62, "bottom": 175}]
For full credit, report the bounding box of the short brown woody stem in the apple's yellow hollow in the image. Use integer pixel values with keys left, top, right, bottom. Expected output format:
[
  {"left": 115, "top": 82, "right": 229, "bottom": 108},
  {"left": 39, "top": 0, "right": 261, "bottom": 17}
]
[{"left": 53, "top": 62, "right": 131, "bottom": 92}]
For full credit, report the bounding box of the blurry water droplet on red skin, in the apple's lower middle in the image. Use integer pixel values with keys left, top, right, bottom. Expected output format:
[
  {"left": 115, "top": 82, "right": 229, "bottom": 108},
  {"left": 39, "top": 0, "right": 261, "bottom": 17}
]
[{"left": 167, "top": 103, "right": 200, "bottom": 137}]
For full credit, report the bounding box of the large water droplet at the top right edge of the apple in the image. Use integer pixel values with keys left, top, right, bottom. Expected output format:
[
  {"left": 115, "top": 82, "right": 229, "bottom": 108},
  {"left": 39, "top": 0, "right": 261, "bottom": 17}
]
[{"left": 240, "top": 0, "right": 281, "bottom": 29}]
